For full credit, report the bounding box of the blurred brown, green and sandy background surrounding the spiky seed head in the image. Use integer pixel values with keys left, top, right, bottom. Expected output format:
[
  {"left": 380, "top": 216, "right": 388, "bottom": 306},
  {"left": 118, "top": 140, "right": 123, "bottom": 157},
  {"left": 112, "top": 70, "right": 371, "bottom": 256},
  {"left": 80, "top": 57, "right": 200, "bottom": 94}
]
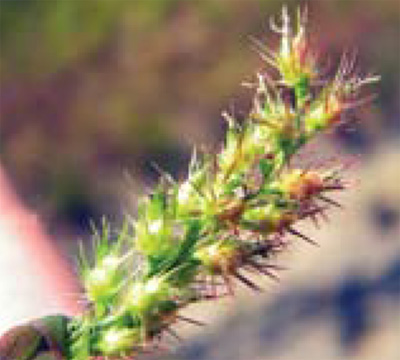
[{"left": 0, "top": 0, "right": 400, "bottom": 360}]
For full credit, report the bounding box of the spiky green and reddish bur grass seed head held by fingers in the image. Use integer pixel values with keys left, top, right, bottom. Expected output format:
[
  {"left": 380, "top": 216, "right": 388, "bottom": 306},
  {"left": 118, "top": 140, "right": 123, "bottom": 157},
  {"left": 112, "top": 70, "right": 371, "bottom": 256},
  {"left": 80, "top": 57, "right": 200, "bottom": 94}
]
[{"left": 71, "top": 8, "right": 377, "bottom": 360}]
